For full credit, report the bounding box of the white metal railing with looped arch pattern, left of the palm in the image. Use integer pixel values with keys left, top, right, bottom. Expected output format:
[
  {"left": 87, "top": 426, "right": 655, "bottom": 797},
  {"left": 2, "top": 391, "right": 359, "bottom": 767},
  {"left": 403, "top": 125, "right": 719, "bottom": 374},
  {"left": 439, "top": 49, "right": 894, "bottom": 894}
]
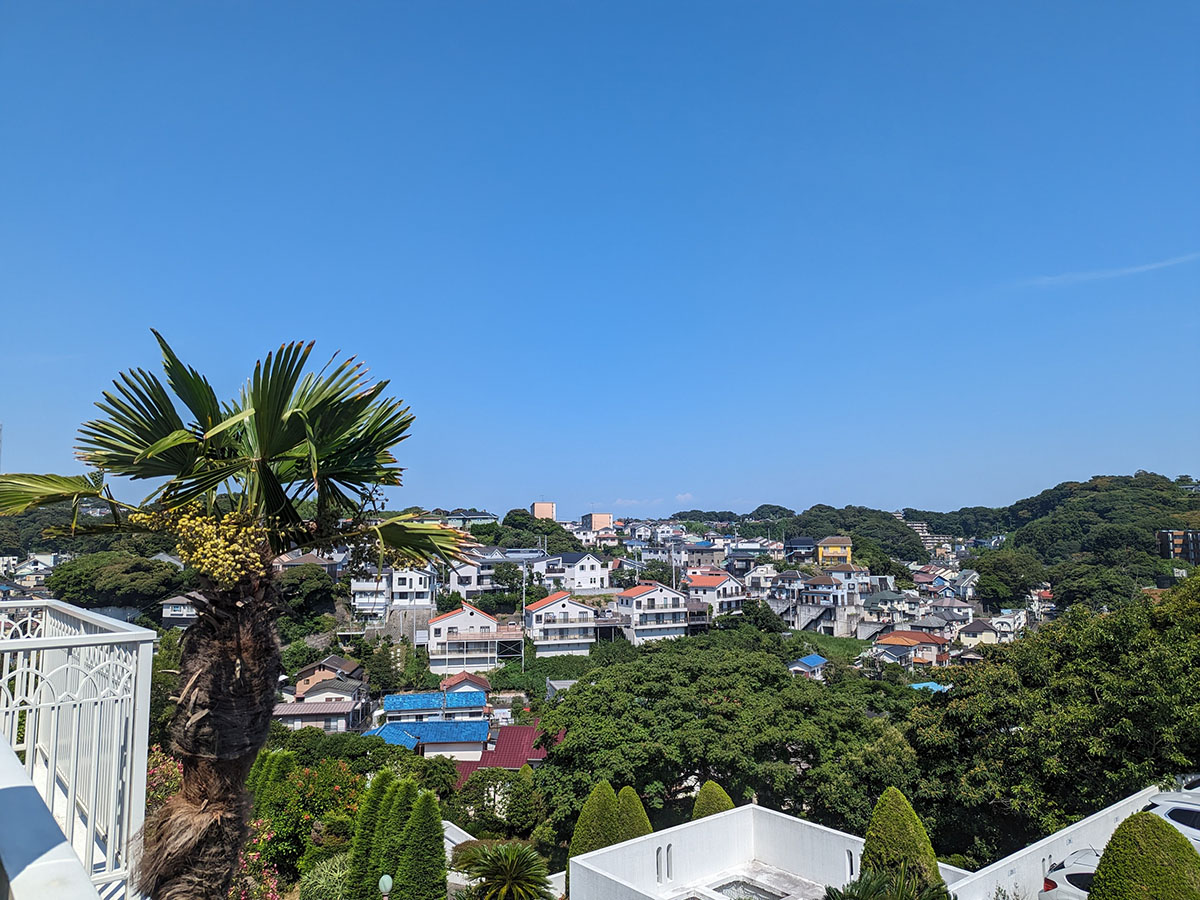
[{"left": 0, "top": 600, "right": 155, "bottom": 896}]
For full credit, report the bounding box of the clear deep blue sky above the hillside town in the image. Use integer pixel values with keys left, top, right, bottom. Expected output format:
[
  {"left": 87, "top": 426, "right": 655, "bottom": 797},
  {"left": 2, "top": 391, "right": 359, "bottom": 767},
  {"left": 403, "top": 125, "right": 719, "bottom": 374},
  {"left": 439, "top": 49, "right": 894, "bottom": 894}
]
[{"left": 0, "top": 0, "right": 1200, "bottom": 516}]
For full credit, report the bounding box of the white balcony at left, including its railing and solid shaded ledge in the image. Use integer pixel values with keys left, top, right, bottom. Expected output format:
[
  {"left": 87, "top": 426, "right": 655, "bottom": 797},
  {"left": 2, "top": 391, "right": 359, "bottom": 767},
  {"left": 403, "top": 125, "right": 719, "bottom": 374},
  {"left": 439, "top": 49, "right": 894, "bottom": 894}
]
[{"left": 0, "top": 600, "right": 155, "bottom": 900}]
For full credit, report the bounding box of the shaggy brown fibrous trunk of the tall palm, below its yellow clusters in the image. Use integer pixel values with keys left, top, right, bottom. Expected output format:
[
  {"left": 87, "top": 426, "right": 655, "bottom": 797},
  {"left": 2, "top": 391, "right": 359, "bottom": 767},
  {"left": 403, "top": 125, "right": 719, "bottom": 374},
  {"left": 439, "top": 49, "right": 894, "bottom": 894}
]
[{"left": 137, "top": 574, "right": 281, "bottom": 900}]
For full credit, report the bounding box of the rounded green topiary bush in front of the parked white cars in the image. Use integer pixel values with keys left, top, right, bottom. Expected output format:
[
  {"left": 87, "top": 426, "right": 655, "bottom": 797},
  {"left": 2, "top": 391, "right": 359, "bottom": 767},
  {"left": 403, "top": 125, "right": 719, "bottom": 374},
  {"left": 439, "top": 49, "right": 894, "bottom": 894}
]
[{"left": 1088, "top": 812, "right": 1200, "bottom": 900}]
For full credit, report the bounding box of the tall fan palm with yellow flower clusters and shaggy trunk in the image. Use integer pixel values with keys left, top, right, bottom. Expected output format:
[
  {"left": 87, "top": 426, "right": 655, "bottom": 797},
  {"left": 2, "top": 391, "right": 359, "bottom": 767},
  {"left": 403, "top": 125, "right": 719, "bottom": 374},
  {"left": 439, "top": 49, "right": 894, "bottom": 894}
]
[{"left": 0, "top": 331, "right": 468, "bottom": 900}]
